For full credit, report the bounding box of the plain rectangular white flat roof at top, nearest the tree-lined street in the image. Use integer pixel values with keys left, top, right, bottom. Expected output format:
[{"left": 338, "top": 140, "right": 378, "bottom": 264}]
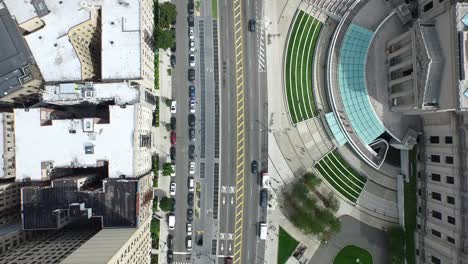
[{"left": 101, "top": 0, "right": 141, "bottom": 80}]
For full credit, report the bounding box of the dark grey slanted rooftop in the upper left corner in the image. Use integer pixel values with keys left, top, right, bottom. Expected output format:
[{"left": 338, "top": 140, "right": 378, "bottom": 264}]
[{"left": 0, "top": 2, "right": 34, "bottom": 96}]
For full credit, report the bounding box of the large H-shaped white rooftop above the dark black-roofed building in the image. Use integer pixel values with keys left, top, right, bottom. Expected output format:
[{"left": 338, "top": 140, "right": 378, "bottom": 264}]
[{"left": 14, "top": 105, "right": 136, "bottom": 181}]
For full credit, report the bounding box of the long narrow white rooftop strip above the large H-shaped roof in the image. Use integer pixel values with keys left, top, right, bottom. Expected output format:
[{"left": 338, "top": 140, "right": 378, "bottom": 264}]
[{"left": 42, "top": 82, "right": 139, "bottom": 105}]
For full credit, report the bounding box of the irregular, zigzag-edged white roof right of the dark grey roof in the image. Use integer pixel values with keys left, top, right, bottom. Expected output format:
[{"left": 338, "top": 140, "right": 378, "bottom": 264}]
[{"left": 16, "top": 0, "right": 91, "bottom": 81}]
